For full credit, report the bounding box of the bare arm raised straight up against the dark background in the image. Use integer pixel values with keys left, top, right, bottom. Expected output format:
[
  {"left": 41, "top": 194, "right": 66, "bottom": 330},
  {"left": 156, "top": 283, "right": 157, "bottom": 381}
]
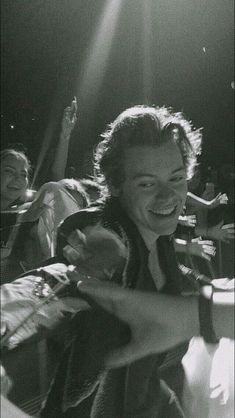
[{"left": 52, "top": 97, "right": 77, "bottom": 181}]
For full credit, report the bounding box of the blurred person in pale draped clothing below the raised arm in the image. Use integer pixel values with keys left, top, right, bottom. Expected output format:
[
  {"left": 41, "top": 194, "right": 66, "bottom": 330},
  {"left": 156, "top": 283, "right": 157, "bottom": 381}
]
[{"left": 1, "top": 179, "right": 89, "bottom": 283}]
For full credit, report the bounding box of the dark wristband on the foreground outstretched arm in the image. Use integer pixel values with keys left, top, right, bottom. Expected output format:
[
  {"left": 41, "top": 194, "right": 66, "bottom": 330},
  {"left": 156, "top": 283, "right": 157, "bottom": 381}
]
[{"left": 198, "top": 286, "right": 219, "bottom": 344}]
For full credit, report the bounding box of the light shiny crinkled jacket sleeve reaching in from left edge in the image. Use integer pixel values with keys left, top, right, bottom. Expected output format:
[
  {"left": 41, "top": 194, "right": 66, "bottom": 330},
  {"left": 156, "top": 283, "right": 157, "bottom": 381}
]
[{"left": 1, "top": 274, "right": 74, "bottom": 349}]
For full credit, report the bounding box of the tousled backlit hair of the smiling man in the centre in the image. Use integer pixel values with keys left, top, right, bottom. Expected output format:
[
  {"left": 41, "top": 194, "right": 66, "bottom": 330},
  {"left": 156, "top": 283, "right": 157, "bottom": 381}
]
[{"left": 94, "top": 105, "right": 202, "bottom": 195}]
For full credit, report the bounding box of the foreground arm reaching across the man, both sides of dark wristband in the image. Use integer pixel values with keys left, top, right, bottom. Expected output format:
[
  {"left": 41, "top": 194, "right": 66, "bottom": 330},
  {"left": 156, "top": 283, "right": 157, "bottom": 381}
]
[{"left": 72, "top": 273, "right": 234, "bottom": 367}]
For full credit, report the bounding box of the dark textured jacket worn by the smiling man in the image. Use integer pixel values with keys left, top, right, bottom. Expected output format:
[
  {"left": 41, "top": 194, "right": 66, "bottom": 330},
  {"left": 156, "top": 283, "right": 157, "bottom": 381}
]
[{"left": 41, "top": 199, "right": 186, "bottom": 418}]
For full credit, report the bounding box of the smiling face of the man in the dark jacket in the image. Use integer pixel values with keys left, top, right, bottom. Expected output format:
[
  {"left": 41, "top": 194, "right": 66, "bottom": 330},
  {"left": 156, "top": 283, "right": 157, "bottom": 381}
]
[{"left": 118, "top": 141, "right": 187, "bottom": 235}]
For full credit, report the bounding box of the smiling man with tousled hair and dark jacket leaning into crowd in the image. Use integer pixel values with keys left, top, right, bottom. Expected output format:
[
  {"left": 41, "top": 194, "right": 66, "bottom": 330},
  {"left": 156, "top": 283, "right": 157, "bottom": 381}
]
[{"left": 38, "top": 106, "right": 201, "bottom": 418}]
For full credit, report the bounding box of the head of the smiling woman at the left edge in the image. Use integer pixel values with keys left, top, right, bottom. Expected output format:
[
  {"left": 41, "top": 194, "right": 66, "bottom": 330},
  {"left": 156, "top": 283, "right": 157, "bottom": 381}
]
[{"left": 1, "top": 154, "right": 28, "bottom": 205}]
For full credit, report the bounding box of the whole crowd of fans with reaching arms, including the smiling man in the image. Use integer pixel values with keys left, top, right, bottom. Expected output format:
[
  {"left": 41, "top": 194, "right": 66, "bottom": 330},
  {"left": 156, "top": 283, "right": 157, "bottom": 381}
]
[{"left": 1, "top": 99, "right": 235, "bottom": 418}]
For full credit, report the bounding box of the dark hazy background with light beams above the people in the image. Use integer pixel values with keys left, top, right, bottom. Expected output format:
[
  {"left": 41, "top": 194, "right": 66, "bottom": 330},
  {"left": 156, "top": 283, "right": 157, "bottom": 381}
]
[{"left": 1, "top": 0, "right": 234, "bottom": 185}]
